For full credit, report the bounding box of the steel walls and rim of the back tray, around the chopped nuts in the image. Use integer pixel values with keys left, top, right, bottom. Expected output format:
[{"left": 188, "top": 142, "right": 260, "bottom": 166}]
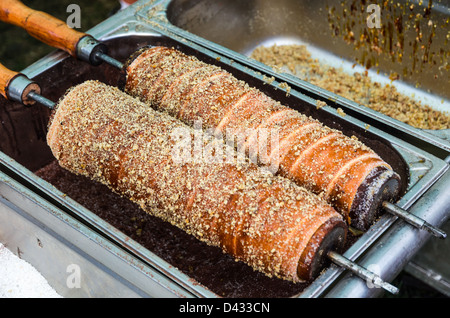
[{"left": 154, "top": 0, "right": 450, "bottom": 151}]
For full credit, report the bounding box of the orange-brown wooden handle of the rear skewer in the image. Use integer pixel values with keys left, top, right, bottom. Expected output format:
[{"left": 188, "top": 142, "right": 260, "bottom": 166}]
[{"left": 0, "top": 0, "right": 87, "bottom": 57}]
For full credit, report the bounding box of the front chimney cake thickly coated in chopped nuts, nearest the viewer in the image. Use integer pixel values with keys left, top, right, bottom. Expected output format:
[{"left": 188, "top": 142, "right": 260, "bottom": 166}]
[{"left": 47, "top": 81, "right": 346, "bottom": 282}]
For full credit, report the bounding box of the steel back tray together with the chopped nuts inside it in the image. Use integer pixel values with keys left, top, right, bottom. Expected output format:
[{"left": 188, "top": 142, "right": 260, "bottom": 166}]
[{"left": 161, "top": 0, "right": 450, "bottom": 151}]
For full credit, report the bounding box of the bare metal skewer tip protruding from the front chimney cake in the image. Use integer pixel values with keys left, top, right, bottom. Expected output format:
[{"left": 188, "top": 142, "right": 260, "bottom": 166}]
[{"left": 327, "top": 251, "right": 399, "bottom": 295}]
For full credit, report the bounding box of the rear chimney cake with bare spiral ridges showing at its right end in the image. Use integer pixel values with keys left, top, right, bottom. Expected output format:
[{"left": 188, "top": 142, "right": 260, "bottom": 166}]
[{"left": 125, "top": 47, "right": 399, "bottom": 230}]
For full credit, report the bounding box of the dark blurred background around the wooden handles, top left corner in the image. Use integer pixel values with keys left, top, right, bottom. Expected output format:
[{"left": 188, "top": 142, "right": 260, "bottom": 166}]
[{"left": 0, "top": 0, "right": 120, "bottom": 71}]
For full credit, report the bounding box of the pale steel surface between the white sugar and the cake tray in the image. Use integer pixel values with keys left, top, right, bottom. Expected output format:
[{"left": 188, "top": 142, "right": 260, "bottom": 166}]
[{"left": 0, "top": 169, "right": 207, "bottom": 298}]
